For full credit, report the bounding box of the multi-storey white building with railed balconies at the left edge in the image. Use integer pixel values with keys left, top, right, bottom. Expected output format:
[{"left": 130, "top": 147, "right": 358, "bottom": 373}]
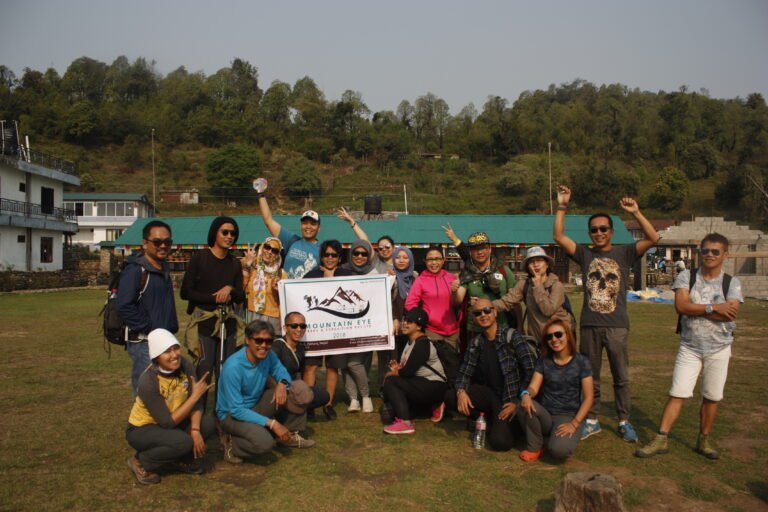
[{"left": 0, "top": 148, "right": 80, "bottom": 272}]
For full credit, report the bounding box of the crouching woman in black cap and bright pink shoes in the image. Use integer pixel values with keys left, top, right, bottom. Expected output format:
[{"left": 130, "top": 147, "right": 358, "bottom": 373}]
[{"left": 384, "top": 308, "right": 447, "bottom": 434}]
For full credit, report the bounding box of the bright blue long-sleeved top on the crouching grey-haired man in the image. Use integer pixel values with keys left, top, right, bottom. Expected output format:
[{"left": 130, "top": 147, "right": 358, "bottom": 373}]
[{"left": 216, "top": 346, "right": 291, "bottom": 427}]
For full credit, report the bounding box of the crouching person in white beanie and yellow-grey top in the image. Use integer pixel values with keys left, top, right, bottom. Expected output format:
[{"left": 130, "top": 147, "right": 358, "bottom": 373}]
[{"left": 125, "top": 329, "right": 216, "bottom": 484}]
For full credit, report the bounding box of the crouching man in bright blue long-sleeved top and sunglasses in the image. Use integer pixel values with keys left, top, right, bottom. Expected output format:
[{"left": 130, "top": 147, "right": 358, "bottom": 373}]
[{"left": 216, "top": 320, "right": 315, "bottom": 464}]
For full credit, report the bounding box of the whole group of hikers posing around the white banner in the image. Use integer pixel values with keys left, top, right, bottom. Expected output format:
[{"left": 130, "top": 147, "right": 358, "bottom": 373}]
[{"left": 118, "top": 182, "right": 743, "bottom": 483}]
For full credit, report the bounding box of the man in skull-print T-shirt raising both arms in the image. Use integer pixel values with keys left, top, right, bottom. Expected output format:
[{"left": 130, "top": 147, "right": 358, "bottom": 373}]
[{"left": 553, "top": 185, "right": 659, "bottom": 443}]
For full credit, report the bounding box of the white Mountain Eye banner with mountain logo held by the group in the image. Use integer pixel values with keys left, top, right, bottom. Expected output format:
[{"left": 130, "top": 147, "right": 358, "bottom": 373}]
[{"left": 279, "top": 275, "right": 395, "bottom": 356}]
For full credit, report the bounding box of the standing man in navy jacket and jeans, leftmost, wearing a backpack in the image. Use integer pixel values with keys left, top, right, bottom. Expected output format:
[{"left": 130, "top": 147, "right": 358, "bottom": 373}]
[{"left": 117, "top": 220, "right": 179, "bottom": 394}]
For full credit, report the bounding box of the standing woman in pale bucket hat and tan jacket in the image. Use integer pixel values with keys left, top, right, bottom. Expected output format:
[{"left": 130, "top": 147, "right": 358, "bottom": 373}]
[{"left": 493, "top": 246, "right": 576, "bottom": 340}]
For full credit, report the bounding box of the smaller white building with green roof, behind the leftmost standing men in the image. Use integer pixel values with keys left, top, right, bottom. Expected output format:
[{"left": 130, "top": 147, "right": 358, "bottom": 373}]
[{"left": 64, "top": 192, "right": 155, "bottom": 250}]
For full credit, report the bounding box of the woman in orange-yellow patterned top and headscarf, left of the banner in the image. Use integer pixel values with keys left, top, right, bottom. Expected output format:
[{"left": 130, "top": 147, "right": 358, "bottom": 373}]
[{"left": 243, "top": 236, "right": 288, "bottom": 332}]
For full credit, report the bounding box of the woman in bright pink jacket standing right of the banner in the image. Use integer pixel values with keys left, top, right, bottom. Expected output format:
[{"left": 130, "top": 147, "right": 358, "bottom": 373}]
[{"left": 405, "top": 247, "right": 459, "bottom": 351}]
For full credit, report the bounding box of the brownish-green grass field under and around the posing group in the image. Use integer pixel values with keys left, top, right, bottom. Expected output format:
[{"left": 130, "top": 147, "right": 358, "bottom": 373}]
[{"left": 0, "top": 290, "right": 768, "bottom": 511}]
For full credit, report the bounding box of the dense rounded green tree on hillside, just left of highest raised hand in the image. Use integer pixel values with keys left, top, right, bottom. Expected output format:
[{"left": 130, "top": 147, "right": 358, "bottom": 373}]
[{"left": 205, "top": 144, "right": 262, "bottom": 197}]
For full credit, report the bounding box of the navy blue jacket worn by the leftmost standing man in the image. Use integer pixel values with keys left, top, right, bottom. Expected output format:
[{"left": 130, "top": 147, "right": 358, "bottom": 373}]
[{"left": 117, "top": 253, "right": 179, "bottom": 334}]
